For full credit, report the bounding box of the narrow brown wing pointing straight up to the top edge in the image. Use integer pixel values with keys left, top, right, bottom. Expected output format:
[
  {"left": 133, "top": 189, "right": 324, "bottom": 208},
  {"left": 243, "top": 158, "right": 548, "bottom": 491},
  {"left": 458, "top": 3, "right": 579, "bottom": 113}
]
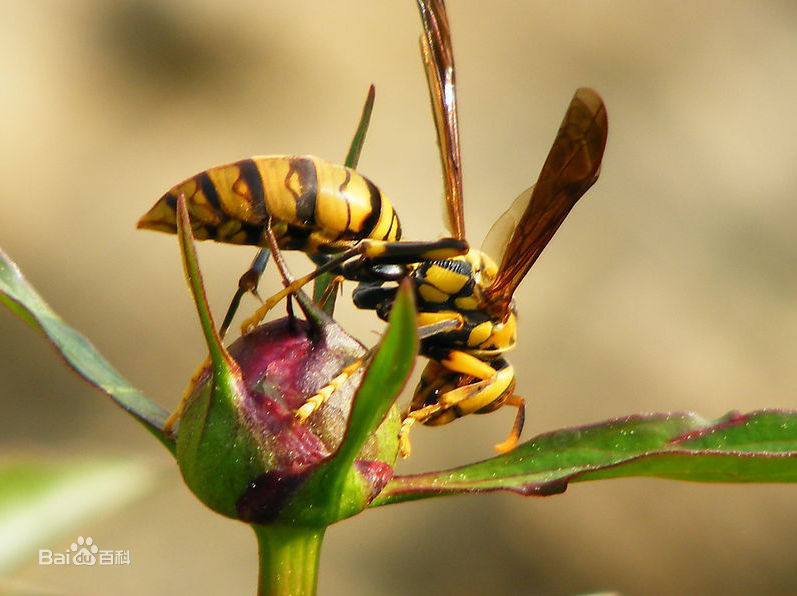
[{"left": 417, "top": 0, "right": 465, "bottom": 240}]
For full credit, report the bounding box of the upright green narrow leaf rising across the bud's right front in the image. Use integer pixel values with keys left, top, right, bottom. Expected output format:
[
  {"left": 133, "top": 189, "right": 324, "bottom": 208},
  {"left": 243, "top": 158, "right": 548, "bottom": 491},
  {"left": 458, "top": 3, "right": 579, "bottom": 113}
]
[{"left": 294, "top": 281, "right": 418, "bottom": 524}]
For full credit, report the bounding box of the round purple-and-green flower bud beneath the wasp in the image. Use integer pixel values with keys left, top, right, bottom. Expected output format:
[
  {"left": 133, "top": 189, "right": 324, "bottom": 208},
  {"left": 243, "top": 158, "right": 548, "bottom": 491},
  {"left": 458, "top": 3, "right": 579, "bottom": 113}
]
[{"left": 177, "top": 318, "right": 398, "bottom": 524}]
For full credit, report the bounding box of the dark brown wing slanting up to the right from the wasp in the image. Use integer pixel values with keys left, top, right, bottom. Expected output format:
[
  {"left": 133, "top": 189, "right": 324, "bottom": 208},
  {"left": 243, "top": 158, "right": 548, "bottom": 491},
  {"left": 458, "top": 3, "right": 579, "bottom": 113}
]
[{"left": 485, "top": 87, "right": 608, "bottom": 315}]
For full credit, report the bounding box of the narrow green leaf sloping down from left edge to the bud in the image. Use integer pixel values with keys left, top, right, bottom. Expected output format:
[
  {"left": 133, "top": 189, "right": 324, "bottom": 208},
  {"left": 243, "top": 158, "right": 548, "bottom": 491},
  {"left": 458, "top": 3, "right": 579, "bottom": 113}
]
[{"left": 0, "top": 250, "right": 174, "bottom": 452}]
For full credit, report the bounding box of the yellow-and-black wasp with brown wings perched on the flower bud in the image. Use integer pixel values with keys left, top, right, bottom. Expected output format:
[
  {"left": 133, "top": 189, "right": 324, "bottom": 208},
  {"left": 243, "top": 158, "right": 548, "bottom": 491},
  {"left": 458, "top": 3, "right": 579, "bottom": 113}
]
[{"left": 139, "top": 0, "right": 608, "bottom": 457}]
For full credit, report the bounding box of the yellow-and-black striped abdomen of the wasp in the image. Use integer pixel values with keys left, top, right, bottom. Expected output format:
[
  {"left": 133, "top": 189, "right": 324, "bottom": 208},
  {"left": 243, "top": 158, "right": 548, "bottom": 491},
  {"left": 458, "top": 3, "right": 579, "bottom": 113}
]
[{"left": 138, "top": 156, "right": 401, "bottom": 252}]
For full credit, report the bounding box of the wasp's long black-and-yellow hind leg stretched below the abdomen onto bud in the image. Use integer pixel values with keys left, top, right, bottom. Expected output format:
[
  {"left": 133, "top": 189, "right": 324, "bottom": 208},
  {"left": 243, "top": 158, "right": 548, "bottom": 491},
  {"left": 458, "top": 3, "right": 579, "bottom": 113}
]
[{"left": 241, "top": 235, "right": 468, "bottom": 333}]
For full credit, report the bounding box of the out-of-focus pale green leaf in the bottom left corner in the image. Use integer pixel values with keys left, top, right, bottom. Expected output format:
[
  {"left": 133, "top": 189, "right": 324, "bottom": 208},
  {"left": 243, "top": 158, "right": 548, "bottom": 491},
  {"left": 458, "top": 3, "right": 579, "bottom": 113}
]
[{"left": 0, "top": 458, "right": 156, "bottom": 572}]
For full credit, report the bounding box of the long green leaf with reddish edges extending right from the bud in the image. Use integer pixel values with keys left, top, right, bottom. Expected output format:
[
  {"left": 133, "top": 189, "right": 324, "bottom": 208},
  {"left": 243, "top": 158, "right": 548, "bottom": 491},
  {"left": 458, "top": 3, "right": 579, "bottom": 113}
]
[{"left": 372, "top": 410, "right": 797, "bottom": 506}]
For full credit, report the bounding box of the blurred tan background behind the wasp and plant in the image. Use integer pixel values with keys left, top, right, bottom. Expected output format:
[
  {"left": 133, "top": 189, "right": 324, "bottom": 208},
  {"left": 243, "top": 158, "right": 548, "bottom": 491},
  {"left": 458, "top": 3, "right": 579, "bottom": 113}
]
[{"left": 0, "top": 0, "right": 797, "bottom": 595}]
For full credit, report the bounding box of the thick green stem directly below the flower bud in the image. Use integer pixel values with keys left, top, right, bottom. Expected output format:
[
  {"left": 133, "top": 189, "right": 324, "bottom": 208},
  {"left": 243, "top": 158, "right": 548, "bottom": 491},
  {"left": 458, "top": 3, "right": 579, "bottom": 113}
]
[{"left": 252, "top": 525, "right": 326, "bottom": 596}]
